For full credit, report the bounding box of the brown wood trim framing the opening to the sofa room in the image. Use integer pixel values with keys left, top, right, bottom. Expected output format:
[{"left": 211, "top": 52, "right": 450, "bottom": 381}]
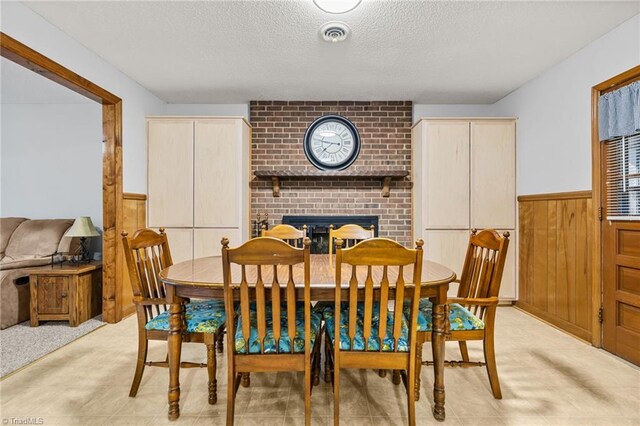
[{"left": 0, "top": 32, "right": 123, "bottom": 323}]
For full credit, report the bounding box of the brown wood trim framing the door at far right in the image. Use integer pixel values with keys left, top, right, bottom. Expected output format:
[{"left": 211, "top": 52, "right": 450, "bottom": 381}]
[{"left": 591, "top": 65, "right": 640, "bottom": 348}]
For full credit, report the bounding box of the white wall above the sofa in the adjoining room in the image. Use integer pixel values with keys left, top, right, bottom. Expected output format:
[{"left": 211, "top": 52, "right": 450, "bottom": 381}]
[{"left": 0, "top": 103, "right": 102, "bottom": 227}]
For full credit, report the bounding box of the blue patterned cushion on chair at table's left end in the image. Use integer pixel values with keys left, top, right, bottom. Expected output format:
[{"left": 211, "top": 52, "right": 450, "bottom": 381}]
[{"left": 144, "top": 300, "right": 225, "bottom": 333}]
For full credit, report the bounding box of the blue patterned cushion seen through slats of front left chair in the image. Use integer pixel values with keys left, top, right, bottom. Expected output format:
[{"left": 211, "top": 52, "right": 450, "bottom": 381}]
[{"left": 236, "top": 302, "right": 322, "bottom": 354}]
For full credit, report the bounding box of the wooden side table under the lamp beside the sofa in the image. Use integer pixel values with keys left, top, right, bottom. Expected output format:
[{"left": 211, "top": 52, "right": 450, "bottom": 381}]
[{"left": 28, "top": 261, "right": 102, "bottom": 327}]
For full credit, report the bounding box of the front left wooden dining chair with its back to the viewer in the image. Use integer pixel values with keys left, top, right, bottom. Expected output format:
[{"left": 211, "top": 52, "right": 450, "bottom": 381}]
[{"left": 222, "top": 237, "right": 322, "bottom": 425}]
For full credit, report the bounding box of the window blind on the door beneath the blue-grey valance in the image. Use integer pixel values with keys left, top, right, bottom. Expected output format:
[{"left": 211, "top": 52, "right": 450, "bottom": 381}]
[{"left": 605, "top": 133, "right": 640, "bottom": 220}]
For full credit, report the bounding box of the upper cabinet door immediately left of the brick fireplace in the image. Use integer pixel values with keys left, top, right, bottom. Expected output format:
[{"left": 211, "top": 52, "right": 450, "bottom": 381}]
[{"left": 194, "top": 119, "right": 244, "bottom": 228}]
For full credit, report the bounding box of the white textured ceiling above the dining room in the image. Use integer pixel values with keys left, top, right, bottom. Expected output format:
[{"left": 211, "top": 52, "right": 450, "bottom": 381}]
[{"left": 25, "top": 0, "right": 640, "bottom": 103}]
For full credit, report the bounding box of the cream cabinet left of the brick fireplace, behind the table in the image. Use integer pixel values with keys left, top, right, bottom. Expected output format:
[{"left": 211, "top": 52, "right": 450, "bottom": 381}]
[{"left": 147, "top": 117, "right": 251, "bottom": 262}]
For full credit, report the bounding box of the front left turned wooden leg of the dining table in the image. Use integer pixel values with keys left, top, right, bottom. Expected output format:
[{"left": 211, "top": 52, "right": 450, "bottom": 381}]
[{"left": 168, "top": 302, "right": 184, "bottom": 420}]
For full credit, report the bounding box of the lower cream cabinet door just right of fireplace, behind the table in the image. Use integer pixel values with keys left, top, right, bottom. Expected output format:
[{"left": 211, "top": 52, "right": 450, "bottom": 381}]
[{"left": 424, "top": 230, "right": 469, "bottom": 297}]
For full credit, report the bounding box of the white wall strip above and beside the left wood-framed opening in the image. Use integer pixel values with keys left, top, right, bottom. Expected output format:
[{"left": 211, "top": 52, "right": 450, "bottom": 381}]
[{"left": 1, "top": 2, "right": 166, "bottom": 193}]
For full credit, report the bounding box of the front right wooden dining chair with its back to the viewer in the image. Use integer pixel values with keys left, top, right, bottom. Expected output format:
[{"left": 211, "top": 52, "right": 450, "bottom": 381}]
[{"left": 324, "top": 238, "right": 423, "bottom": 425}]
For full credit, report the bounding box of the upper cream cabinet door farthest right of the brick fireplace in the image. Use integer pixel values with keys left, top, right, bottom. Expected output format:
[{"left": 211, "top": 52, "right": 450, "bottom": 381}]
[{"left": 471, "top": 121, "right": 516, "bottom": 229}]
